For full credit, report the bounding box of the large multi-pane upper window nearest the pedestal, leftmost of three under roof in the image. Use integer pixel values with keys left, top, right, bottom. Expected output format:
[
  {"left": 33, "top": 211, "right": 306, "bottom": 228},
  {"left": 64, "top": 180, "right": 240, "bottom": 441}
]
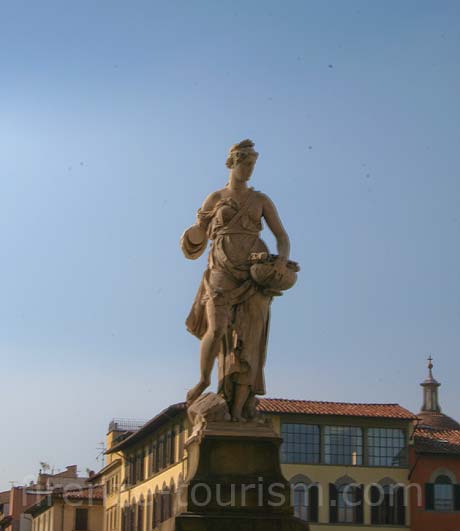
[{"left": 281, "top": 424, "right": 321, "bottom": 463}]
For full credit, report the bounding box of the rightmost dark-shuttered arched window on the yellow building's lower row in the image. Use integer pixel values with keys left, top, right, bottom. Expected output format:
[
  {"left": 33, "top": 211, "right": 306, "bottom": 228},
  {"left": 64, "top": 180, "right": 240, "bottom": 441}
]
[{"left": 370, "top": 485, "right": 406, "bottom": 525}]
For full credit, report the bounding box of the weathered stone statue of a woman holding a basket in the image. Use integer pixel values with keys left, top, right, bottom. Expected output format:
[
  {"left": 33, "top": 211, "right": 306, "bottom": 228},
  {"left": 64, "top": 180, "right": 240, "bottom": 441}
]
[{"left": 181, "top": 140, "right": 299, "bottom": 422}]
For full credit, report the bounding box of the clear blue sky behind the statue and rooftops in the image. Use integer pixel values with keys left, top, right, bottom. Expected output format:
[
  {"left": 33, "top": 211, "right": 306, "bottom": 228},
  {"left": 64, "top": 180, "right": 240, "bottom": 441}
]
[{"left": 0, "top": 0, "right": 460, "bottom": 489}]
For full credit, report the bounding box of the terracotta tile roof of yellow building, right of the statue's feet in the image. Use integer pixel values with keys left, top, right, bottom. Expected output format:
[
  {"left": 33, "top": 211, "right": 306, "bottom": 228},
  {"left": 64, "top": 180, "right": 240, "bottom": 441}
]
[{"left": 259, "top": 398, "right": 416, "bottom": 420}]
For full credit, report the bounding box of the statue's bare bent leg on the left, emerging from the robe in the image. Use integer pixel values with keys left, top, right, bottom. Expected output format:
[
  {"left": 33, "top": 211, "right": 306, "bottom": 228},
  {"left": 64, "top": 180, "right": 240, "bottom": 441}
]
[{"left": 187, "top": 299, "right": 228, "bottom": 404}]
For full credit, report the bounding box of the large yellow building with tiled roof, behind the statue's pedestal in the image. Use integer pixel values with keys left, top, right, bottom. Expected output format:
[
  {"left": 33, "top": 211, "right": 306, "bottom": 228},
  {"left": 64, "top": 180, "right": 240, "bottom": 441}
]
[{"left": 93, "top": 399, "right": 415, "bottom": 531}]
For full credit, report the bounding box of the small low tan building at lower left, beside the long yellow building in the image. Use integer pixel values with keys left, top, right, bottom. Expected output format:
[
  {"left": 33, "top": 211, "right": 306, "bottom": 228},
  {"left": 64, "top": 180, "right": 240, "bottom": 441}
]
[{"left": 25, "top": 487, "right": 104, "bottom": 531}]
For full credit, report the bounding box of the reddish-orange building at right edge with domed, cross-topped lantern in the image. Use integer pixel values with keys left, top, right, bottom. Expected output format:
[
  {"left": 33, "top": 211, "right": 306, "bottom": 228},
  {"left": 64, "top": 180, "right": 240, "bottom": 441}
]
[{"left": 410, "top": 358, "right": 460, "bottom": 531}]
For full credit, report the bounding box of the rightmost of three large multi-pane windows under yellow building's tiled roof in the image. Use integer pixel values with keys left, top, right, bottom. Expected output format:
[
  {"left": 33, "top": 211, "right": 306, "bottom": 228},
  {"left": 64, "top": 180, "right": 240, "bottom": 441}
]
[{"left": 367, "top": 428, "right": 407, "bottom": 466}]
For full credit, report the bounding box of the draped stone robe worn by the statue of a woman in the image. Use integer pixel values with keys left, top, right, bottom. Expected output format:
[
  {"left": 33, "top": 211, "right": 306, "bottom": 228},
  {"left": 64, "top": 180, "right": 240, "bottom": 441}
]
[{"left": 181, "top": 189, "right": 271, "bottom": 403}]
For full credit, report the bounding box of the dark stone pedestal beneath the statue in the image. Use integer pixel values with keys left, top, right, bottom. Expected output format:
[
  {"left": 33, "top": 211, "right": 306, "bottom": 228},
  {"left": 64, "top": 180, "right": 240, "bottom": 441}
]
[{"left": 175, "top": 422, "right": 309, "bottom": 531}]
